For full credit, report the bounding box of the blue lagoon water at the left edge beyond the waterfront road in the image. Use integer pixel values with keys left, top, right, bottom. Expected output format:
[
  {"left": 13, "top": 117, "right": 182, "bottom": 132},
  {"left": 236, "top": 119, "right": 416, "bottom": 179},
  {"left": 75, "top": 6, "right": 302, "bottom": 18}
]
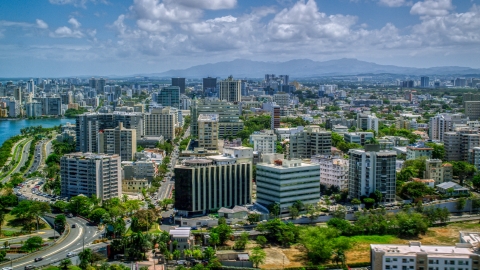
[{"left": 0, "top": 118, "right": 75, "bottom": 145}]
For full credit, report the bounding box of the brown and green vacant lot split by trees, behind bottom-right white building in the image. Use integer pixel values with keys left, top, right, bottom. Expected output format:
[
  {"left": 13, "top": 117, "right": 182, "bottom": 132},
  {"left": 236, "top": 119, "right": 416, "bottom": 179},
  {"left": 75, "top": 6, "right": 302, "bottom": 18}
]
[{"left": 261, "top": 221, "right": 480, "bottom": 269}]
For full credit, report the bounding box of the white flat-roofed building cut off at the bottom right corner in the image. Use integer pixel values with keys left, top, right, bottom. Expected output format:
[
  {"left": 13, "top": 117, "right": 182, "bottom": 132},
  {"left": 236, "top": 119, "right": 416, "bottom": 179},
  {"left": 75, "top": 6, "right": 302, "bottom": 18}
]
[{"left": 370, "top": 242, "right": 480, "bottom": 270}]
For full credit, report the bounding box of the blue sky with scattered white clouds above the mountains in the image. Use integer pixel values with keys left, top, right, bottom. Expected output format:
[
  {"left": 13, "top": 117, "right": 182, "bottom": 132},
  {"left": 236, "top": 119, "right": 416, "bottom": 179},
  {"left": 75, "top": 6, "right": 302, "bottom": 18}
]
[{"left": 0, "top": 0, "right": 480, "bottom": 78}]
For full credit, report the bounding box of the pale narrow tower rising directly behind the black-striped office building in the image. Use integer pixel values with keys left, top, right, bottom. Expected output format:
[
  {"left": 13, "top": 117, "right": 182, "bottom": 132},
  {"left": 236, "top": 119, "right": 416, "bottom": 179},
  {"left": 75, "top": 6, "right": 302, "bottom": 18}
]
[{"left": 197, "top": 114, "right": 218, "bottom": 150}]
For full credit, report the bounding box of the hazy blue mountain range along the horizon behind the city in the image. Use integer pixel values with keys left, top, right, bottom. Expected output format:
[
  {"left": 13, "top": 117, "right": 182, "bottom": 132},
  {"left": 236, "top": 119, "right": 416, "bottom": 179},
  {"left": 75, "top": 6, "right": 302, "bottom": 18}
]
[{"left": 148, "top": 58, "right": 480, "bottom": 78}]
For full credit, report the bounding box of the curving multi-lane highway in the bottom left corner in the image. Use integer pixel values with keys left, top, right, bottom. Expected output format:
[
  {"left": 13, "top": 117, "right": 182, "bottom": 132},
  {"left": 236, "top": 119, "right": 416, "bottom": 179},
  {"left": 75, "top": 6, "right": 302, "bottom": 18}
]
[{"left": 3, "top": 218, "right": 105, "bottom": 269}]
